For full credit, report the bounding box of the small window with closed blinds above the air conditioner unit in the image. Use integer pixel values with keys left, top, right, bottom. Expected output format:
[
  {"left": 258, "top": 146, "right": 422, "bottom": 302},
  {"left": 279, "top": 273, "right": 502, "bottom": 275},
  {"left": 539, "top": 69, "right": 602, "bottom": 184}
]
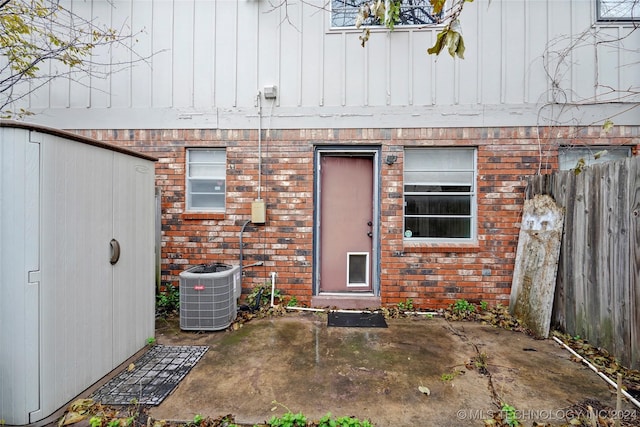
[{"left": 187, "top": 148, "right": 227, "bottom": 212}]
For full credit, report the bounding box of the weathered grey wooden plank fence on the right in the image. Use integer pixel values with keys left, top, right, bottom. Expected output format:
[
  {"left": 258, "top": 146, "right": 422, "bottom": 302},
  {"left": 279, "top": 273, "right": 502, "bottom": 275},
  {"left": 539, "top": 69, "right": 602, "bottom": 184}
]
[{"left": 526, "top": 157, "right": 640, "bottom": 369}]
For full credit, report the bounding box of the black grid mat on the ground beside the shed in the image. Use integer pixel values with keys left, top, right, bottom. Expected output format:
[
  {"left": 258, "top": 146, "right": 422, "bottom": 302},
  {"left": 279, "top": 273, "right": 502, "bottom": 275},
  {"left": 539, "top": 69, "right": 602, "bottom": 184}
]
[{"left": 91, "top": 345, "right": 209, "bottom": 406}]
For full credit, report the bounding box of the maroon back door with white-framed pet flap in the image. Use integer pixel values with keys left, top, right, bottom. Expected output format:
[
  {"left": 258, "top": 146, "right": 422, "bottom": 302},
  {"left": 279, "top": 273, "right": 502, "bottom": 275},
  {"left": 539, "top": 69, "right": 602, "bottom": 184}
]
[{"left": 319, "top": 154, "right": 373, "bottom": 293}]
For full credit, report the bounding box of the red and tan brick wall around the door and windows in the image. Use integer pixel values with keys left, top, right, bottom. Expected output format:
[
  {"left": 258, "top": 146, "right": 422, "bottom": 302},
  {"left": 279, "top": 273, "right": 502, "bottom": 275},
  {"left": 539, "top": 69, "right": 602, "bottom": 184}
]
[{"left": 77, "top": 127, "right": 640, "bottom": 309}]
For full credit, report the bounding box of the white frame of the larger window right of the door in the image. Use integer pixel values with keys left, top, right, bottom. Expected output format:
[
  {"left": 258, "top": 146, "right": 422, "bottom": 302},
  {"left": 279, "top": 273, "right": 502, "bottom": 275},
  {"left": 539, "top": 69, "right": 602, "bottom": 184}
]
[{"left": 402, "top": 147, "right": 478, "bottom": 243}]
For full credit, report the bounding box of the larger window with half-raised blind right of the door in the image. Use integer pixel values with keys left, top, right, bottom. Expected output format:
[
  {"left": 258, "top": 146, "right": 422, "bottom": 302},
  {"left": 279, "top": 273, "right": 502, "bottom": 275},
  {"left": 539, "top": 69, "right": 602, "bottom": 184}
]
[{"left": 404, "top": 148, "right": 476, "bottom": 242}]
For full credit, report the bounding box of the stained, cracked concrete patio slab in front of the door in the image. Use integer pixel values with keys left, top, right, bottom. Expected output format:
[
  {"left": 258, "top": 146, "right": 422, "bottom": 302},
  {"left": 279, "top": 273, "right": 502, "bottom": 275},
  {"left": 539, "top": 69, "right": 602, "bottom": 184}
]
[{"left": 150, "top": 312, "right": 640, "bottom": 426}]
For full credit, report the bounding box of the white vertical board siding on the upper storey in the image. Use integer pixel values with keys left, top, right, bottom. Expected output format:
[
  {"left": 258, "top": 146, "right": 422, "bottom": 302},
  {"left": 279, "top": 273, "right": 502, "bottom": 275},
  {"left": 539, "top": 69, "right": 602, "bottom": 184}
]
[{"left": 16, "top": 0, "right": 640, "bottom": 128}]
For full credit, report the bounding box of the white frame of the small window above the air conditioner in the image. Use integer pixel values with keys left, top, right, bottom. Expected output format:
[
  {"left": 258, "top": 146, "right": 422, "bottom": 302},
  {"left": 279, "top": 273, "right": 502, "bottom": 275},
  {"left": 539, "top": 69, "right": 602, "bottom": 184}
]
[{"left": 185, "top": 147, "right": 227, "bottom": 212}]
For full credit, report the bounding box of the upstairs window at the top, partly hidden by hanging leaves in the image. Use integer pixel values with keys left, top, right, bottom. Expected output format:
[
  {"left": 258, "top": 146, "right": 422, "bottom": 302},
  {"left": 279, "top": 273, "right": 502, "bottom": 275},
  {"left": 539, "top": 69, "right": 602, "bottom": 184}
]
[{"left": 331, "top": 0, "right": 442, "bottom": 27}]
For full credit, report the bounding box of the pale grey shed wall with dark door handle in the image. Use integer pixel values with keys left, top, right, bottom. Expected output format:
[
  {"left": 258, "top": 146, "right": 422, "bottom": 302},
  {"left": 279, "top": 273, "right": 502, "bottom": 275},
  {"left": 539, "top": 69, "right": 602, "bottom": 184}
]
[{"left": 0, "top": 123, "right": 155, "bottom": 425}]
